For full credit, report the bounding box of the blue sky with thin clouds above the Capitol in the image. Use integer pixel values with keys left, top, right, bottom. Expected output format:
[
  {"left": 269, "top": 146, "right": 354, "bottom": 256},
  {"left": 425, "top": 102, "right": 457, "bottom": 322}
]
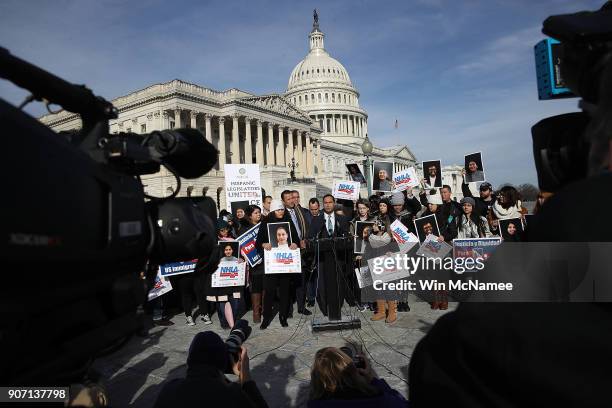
[{"left": 0, "top": 0, "right": 603, "bottom": 185}]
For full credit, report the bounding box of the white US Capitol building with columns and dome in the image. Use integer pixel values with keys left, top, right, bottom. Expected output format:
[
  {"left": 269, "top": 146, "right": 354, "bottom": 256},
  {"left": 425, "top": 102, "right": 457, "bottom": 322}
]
[{"left": 40, "top": 16, "right": 461, "bottom": 208}]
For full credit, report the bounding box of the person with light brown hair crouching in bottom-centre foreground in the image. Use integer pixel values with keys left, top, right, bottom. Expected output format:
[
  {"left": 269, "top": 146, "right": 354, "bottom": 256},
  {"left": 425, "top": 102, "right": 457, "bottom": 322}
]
[{"left": 308, "top": 347, "right": 408, "bottom": 408}]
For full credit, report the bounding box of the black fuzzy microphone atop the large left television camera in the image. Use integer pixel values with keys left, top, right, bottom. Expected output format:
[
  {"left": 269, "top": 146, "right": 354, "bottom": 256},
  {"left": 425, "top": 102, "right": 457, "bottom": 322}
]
[{"left": 143, "top": 129, "right": 219, "bottom": 178}]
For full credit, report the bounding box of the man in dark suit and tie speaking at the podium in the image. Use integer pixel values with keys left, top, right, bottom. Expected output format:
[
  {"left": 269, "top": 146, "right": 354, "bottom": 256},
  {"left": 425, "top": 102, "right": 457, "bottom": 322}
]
[{"left": 308, "top": 194, "right": 352, "bottom": 320}]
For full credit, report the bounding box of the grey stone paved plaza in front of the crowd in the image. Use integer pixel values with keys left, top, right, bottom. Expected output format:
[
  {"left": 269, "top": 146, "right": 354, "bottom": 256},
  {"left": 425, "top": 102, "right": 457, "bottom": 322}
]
[{"left": 94, "top": 302, "right": 456, "bottom": 407}]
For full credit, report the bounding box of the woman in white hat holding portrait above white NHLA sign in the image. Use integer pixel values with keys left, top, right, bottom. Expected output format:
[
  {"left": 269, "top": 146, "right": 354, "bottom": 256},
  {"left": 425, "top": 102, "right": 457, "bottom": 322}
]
[{"left": 255, "top": 200, "right": 298, "bottom": 330}]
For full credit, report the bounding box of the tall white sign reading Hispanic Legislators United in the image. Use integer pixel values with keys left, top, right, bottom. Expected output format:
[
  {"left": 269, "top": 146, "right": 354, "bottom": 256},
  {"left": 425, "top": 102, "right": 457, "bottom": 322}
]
[{"left": 224, "top": 164, "right": 262, "bottom": 212}]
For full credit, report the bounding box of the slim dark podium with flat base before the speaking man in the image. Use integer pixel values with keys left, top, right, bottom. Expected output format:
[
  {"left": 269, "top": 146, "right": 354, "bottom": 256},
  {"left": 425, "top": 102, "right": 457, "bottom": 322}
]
[{"left": 310, "top": 237, "right": 361, "bottom": 332}]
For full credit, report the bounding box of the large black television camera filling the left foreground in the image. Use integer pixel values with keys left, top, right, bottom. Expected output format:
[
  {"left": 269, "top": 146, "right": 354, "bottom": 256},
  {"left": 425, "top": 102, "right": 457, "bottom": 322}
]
[{"left": 0, "top": 48, "right": 218, "bottom": 386}]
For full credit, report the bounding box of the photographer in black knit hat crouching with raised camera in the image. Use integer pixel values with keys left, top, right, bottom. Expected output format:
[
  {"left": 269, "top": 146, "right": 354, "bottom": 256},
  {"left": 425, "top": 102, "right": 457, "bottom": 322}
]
[{"left": 155, "top": 320, "right": 268, "bottom": 408}]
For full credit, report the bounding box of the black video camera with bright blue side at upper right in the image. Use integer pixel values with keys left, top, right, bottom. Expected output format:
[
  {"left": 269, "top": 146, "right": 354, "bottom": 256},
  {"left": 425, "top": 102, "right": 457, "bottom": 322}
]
[{"left": 531, "top": 1, "right": 612, "bottom": 192}]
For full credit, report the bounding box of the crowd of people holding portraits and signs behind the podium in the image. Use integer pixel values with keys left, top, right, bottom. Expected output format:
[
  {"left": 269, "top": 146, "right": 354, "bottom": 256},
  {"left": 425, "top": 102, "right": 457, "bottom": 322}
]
[{"left": 149, "top": 173, "right": 547, "bottom": 330}]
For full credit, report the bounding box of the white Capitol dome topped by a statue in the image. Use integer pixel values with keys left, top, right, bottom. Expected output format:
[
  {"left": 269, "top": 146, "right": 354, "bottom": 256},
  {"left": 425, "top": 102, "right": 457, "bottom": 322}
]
[{"left": 285, "top": 13, "right": 368, "bottom": 144}]
